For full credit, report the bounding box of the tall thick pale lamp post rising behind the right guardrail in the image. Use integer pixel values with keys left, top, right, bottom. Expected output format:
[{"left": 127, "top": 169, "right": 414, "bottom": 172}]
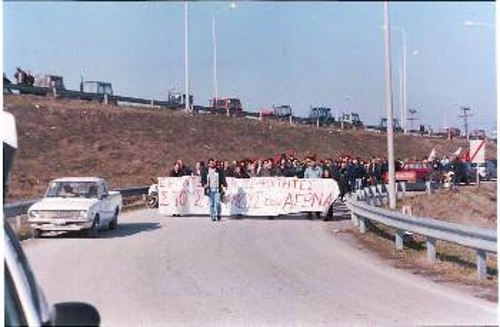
[{"left": 384, "top": 1, "right": 396, "bottom": 210}]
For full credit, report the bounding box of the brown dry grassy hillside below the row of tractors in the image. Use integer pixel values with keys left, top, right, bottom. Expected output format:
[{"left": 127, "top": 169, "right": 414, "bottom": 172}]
[{"left": 4, "top": 95, "right": 496, "bottom": 200}]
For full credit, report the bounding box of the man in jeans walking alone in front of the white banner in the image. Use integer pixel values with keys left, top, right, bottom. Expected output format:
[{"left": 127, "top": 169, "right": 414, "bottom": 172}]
[{"left": 201, "top": 158, "right": 227, "bottom": 221}]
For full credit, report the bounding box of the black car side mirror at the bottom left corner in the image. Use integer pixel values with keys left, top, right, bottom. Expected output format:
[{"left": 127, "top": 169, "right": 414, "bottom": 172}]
[{"left": 53, "top": 302, "right": 101, "bottom": 326}]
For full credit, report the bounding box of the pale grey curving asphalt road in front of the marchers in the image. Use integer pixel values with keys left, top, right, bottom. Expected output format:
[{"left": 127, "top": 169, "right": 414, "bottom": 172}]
[{"left": 23, "top": 210, "right": 497, "bottom": 326}]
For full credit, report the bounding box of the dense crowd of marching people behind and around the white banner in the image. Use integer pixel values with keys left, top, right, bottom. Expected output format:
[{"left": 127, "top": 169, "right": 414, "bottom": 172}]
[{"left": 165, "top": 154, "right": 476, "bottom": 221}]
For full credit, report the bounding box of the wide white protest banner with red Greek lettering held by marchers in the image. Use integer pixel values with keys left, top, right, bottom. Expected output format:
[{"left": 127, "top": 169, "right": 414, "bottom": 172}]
[{"left": 158, "top": 176, "right": 339, "bottom": 216}]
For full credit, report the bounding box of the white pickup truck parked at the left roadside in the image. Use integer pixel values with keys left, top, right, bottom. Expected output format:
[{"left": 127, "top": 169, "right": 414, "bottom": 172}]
[{"left": 28, "top": 177, "right": 122, "bottom": 238}]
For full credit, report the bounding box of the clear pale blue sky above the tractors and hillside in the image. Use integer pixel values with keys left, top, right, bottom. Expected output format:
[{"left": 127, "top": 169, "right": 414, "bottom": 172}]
[{"left": 2, "top": 1, "right": 497, "bottom": 135}]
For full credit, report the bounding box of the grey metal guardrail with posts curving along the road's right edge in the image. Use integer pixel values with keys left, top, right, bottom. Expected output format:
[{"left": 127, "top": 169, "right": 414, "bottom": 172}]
[{"left": 346, "top": 191, "right": 497, "bottom": 279}]
